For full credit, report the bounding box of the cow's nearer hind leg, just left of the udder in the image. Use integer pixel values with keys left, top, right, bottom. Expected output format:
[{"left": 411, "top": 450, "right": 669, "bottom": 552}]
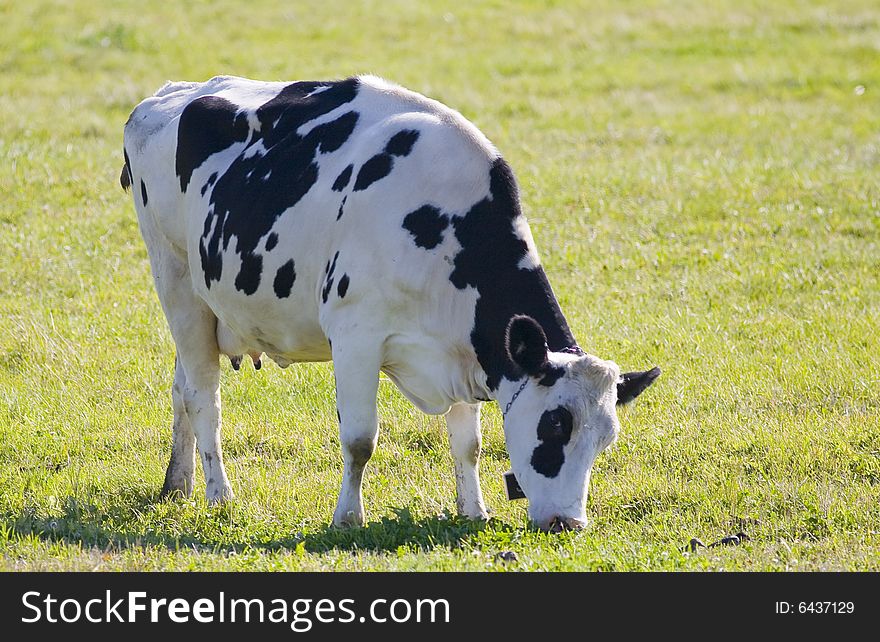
[{"left": 145, "top": 240, "right": 232, "bottom": 503}]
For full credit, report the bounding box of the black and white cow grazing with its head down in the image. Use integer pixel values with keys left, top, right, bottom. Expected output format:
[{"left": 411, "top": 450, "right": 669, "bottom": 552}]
[{"left": 121, "top": 76, "right": 659, "bottom": 530}]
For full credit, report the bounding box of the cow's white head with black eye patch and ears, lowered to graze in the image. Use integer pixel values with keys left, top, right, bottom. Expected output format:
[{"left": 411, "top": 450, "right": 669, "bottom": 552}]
[{"left": 501, "top": 316, "right": 660, "bottom": 531}]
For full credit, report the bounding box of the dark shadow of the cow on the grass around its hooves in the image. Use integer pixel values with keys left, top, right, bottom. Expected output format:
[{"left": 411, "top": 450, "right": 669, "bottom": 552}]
[{"left": 0, "top": 493, "right": 514, "bottom": 553}]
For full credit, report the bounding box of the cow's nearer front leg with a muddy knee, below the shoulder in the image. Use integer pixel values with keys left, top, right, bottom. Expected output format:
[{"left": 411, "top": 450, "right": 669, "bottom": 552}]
[{"left": 333, "top": 340, "right": 381, "bottom": 526}]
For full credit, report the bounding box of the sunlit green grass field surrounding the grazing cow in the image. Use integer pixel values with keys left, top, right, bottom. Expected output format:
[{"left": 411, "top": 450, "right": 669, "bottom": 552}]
[{"left": 0, "top": 0, "right": 880, "bottom": 571}]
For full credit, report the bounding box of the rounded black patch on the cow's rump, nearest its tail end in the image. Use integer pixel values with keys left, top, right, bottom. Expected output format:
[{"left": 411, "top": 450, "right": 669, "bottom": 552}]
[{"left": 175, "top": 96, "right": 250, "bottom": 192}]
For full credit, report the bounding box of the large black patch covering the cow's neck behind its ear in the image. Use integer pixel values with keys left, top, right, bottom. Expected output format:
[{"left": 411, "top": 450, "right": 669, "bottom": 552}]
[{"left": 449, "top": 158, "right": 576, "bottom": 390}]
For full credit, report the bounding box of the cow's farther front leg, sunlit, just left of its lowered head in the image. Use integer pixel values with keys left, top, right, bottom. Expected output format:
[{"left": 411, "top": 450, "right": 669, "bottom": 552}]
[{"left": 446, "top": 403, "right": 489, "bottom": 519}]
